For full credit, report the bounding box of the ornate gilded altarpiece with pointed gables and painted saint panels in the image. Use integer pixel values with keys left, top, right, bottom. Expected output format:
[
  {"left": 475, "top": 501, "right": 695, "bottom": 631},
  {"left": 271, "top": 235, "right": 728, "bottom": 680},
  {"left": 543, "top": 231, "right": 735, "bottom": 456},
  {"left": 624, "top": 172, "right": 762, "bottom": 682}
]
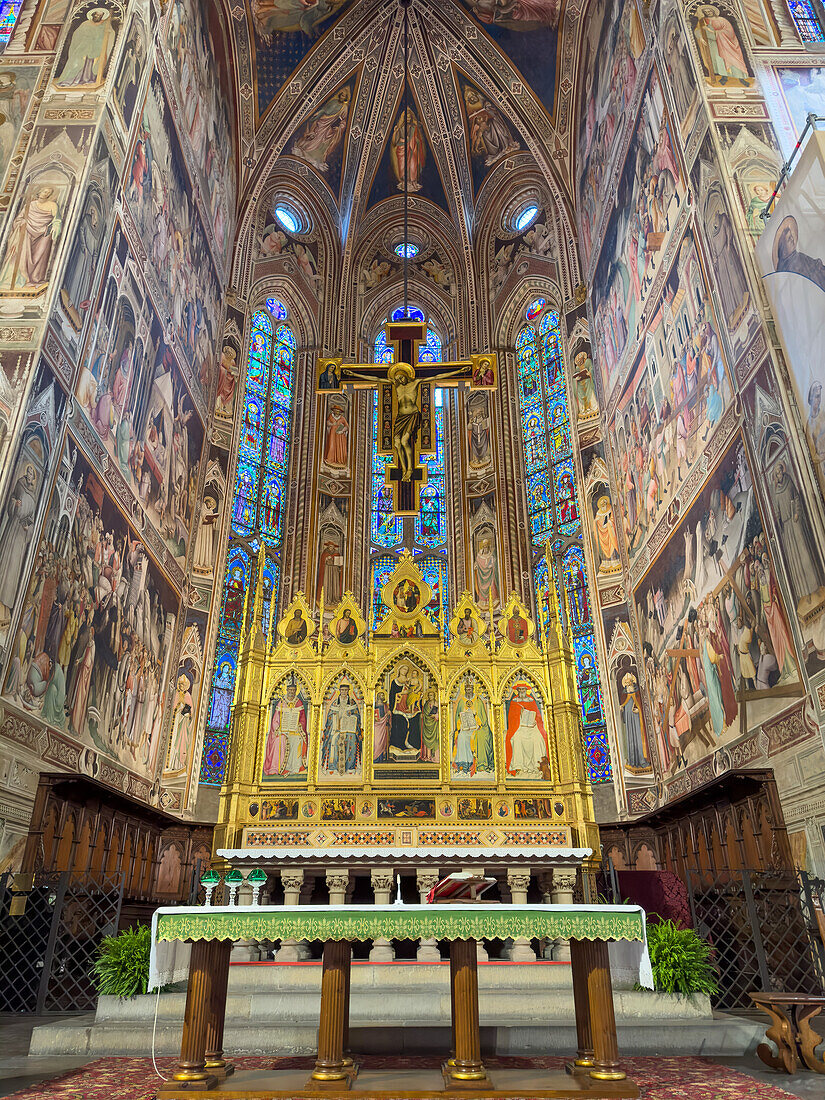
[{"left": 215, "top": 552, "right": 598, "bottom": 854}]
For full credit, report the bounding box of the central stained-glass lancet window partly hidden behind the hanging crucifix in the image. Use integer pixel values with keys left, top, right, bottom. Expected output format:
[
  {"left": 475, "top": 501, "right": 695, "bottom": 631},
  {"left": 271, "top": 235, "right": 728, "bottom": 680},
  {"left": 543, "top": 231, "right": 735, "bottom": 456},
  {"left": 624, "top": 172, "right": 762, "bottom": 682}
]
[{"left": 371, "top": 309, "right": 449, "bottom": 627}]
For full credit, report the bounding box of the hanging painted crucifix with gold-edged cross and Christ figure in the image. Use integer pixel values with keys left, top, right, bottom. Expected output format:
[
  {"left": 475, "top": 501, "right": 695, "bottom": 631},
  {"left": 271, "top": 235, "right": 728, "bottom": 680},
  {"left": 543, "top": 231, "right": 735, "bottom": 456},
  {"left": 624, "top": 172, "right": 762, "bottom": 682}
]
[{"left": 318, "top": 320, "right": 496, "bottom": 516}]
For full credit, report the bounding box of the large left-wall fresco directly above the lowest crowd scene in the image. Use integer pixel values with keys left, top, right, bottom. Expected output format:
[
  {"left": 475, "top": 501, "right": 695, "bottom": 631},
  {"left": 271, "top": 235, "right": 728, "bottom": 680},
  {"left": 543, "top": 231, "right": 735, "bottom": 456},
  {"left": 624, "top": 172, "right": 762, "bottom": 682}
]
[{"left": 76, "top": 230, "right": 204, "bottom": 564}]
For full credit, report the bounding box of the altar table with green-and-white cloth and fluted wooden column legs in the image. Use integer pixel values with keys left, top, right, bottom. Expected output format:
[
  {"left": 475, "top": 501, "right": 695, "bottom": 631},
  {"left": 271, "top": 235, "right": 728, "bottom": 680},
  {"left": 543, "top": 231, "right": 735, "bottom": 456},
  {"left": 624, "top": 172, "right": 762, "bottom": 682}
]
[{"left": 150, "top": 903, "right": 651, "bottom": 1100}]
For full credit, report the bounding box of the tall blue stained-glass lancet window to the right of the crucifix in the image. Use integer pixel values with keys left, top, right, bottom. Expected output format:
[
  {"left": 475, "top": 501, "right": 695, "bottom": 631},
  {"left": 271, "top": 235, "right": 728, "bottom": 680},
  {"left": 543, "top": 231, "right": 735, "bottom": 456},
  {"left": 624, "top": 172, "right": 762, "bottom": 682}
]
[{"left": 516, "top": 298, "right": 613, "bottom": 782}]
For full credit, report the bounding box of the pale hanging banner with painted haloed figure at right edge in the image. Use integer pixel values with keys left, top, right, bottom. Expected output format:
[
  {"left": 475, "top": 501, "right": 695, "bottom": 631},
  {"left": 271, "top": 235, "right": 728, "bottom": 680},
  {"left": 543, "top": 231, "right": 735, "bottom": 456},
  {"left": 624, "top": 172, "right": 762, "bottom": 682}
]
[{"left": 756, "top": 131, "right": 825, "bottom": 503}]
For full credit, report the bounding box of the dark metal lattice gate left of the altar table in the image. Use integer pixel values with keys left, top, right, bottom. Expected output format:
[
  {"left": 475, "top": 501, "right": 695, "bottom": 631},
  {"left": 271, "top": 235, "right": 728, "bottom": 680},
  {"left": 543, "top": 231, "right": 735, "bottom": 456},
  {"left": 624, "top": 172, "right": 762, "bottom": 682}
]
[{"left": 0, "top": 871, "right": 123, "bottom": 1015}]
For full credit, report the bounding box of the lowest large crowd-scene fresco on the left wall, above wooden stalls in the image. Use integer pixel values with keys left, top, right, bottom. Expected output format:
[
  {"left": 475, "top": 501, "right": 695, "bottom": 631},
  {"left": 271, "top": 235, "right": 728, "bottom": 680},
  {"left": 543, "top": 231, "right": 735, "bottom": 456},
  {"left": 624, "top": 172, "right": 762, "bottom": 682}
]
[{"left": 3, "top": 441, "right": 177, "bottom": 778}]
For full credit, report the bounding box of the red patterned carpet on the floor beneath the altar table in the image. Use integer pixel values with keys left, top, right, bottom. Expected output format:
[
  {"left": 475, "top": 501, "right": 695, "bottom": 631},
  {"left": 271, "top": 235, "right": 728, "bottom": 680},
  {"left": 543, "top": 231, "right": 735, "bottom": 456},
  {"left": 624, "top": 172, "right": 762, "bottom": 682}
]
[{"left": 1, "top": 1057, "right": 790, "bottom": 1100}]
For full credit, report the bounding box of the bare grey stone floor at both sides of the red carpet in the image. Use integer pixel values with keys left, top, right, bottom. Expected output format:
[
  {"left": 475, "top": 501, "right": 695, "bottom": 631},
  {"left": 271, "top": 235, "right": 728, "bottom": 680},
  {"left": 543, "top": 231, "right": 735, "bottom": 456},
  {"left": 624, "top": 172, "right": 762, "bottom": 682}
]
[{"left": 0, "top": 1016, "right": 825, "bottom": 1100}]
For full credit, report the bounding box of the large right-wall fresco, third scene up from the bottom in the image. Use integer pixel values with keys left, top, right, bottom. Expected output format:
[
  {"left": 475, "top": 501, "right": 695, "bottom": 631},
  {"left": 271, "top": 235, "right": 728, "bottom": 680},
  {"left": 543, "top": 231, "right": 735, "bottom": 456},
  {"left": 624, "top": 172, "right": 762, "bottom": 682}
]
[{"left": 592, "top": 62, "right": 685, "bottom": 394}]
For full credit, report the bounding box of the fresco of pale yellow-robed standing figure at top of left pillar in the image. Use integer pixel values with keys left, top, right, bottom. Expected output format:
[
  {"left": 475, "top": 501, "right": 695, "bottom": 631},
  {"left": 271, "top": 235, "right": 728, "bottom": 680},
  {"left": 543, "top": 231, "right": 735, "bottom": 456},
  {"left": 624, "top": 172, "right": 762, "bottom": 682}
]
[{"left": 52, "top": 0, "right": 123, "bottom": 92}]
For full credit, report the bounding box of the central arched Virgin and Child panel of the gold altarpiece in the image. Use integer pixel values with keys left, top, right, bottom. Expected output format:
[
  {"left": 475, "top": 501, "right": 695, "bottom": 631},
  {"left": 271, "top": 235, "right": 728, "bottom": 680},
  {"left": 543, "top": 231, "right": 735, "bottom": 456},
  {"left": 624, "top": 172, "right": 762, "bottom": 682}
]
[{"left": 373, "top": 655, "right": 441, "bottom": 781}]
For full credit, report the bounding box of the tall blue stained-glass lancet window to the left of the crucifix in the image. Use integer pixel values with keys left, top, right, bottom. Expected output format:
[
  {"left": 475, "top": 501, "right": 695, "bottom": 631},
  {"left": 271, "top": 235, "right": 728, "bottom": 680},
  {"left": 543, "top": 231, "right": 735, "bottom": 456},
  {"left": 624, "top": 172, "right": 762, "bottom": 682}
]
[{"left": 200, "top": 298, "right": 296, "bottom": 785}]
